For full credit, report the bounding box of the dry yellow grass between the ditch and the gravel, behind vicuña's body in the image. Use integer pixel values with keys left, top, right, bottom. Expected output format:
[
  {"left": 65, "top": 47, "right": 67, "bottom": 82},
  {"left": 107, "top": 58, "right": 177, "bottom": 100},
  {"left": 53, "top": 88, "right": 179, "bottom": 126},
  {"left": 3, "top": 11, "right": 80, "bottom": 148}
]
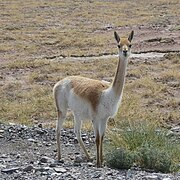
[{"left": 0, "top": 54, "right": 180, "bottom": 127}]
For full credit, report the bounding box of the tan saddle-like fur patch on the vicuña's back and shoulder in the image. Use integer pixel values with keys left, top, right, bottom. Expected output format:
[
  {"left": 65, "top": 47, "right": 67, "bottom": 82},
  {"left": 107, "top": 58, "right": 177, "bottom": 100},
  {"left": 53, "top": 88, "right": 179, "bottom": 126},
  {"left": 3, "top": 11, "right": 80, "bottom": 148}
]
[{"left": 69, "top": 76, "right": 109, "bottom": 111}]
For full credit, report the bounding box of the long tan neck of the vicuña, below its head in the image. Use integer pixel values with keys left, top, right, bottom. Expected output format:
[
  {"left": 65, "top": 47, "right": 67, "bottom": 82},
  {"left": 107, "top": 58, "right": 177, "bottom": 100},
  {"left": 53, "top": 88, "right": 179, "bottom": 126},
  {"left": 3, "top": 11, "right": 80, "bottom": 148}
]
[{"left": 112, "top": 57, "right": 128, "bottom": 97}]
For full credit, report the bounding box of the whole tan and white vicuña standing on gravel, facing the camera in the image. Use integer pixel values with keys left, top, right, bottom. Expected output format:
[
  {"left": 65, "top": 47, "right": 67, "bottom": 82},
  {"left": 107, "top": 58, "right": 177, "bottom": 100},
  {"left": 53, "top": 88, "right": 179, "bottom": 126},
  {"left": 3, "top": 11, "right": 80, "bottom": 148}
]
[{"left": 53, "top": 31, "right": 134, "bottom": 167}]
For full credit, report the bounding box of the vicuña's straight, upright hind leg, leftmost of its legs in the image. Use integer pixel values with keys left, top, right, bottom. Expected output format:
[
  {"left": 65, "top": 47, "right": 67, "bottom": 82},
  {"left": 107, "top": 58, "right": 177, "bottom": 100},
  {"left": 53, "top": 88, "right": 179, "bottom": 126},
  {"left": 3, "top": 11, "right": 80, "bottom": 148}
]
[{"left": 56, "top": 111, "right": 66, "bottom": 160}]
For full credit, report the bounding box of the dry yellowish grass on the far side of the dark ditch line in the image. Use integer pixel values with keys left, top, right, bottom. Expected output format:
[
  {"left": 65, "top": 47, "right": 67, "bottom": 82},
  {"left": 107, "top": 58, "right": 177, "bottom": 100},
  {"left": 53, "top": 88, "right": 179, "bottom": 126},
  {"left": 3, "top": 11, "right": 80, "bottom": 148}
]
[{"left": 0, "top": 0, "right": 179, "bottom": 61}]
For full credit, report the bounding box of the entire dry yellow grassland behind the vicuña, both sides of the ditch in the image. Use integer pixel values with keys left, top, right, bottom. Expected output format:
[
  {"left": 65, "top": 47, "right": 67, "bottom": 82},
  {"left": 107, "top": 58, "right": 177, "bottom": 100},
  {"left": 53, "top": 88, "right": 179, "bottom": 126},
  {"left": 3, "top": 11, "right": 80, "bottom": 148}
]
[{"left": 0, "top": 0, "right": 179, "bottom": 130}]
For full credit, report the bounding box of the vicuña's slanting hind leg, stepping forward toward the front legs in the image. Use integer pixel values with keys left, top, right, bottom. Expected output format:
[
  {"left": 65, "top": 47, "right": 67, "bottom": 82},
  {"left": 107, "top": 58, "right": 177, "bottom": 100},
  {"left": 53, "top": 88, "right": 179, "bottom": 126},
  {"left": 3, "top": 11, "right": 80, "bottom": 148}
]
[{"left": 74, "top": 118, "right": 90, "bottom": 160}]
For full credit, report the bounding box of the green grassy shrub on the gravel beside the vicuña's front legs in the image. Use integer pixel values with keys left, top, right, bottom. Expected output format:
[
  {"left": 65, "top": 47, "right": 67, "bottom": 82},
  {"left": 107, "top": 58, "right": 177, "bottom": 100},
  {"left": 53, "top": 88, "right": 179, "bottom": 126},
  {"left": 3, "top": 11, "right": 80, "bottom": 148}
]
[{"left": 106, "top": 121, "right": 180, "bottom": 173}]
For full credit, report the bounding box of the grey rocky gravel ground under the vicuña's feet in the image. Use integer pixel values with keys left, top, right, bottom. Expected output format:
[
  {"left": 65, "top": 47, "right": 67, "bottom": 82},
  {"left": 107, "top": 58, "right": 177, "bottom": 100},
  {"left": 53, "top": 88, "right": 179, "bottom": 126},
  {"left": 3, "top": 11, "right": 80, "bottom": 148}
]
[{"left": 0, "top": 124, "right": 180, "bottom": 180}]
